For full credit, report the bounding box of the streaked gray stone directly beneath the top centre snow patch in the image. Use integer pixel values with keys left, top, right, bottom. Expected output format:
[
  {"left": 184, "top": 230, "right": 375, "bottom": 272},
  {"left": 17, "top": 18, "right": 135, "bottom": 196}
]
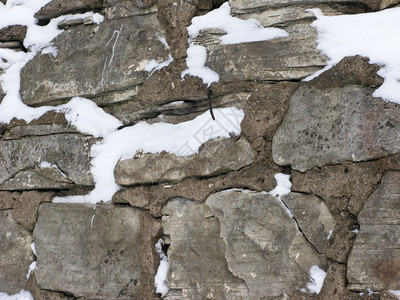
[{"left": 200, "top": 23, "right": 327, "bottom": 82}]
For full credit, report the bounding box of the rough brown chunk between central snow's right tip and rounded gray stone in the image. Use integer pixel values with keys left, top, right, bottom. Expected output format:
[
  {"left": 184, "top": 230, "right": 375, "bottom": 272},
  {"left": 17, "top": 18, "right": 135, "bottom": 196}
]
[{"left": 240, "top": 82, "right": 298, "bottom": 142}]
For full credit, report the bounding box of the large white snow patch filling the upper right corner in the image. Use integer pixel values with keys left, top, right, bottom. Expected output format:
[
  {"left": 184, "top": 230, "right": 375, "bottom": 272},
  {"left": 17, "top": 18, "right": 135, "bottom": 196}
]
[{"left": 306, "top": 7, "right": 400, "bottom": 104}]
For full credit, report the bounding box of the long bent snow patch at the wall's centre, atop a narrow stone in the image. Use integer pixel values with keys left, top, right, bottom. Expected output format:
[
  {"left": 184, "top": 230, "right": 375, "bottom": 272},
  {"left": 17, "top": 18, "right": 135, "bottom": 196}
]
[{"left": 53, "top": 107, "right": 244, "bottom": 203}]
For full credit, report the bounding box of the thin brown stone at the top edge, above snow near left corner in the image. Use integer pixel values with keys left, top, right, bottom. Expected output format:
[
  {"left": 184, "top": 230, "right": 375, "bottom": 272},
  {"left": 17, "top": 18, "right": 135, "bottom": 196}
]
[{"left": 34, "top": 0, "right": 103, "bottom": 20}]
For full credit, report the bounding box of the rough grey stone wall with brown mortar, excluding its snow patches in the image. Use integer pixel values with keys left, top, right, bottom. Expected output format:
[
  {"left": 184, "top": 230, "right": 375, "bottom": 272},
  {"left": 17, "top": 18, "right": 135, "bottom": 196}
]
[{"left": 0, "top": 0, "right": 400, "bottom": 300}]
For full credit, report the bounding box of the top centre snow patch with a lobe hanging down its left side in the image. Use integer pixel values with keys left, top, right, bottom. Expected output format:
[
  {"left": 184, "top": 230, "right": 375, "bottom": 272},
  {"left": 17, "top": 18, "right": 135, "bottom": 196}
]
[{"left": 181, "top": 2, "right": 288, "bottom": 86}]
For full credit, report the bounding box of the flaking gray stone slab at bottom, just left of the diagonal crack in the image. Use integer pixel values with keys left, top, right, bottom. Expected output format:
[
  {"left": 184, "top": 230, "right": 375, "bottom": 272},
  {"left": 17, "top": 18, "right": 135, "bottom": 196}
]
[{"left": 206, "top": 191, "right": 324, "bottom": 299}]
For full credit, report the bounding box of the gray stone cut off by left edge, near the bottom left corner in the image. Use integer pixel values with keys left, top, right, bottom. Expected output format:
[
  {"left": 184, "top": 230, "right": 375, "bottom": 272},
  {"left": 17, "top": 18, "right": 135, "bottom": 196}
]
[{"left": 0, "top": 210, "right": 33, "bottom": 295}]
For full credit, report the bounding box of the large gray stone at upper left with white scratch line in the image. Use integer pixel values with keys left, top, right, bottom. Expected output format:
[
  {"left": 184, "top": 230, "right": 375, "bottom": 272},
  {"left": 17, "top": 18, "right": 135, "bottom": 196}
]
[{"left": 21, "top": 14, "right": 169, "bottom": 106}]
